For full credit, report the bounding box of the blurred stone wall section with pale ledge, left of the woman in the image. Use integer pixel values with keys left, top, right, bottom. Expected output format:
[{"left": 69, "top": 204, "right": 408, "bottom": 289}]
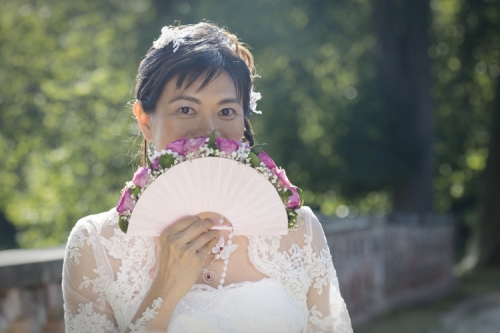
[{"left": 0, "top": 246, "right": 64, "bottom": 333}]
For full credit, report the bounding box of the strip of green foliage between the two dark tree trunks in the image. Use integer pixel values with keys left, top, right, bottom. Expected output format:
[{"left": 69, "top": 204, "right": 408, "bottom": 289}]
[{"left": 428, "top": 0, "right": 500, "bottom": 228}]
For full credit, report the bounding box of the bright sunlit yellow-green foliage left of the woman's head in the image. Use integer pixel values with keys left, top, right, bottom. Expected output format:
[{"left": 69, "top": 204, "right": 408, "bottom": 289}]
[{"left": 0, "top": 1, "right": 151, "bottom": 247}]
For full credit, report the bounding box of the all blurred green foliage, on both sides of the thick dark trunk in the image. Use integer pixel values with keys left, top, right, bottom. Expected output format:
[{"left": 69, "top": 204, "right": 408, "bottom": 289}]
[{"left": 0, "top": 0, "right": 500, "bottom": 247}]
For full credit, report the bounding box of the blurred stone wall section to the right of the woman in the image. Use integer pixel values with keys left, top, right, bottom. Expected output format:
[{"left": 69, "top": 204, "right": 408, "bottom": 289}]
[{"left": 320, "top": 215, "right": 456, "bottom": 325}]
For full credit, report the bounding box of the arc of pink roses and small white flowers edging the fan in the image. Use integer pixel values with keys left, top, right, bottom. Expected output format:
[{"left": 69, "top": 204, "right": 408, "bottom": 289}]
[{"left": 116, "top": 132, "right": 303, "bottom": 232}]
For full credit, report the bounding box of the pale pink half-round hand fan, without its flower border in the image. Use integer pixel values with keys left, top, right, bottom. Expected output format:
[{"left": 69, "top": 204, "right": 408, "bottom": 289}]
[{"left": 127, "top": 157, "right": 288, "bottom": 237}]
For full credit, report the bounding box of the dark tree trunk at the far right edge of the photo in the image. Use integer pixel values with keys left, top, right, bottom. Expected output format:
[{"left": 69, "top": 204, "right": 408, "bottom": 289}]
[{"left": 462, "top": 0, "right": 500, "bottom": 265}]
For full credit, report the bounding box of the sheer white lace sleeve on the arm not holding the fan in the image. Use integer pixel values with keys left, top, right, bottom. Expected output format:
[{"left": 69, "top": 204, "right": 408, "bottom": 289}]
[{"left": 304, "top": 209, "right": 352, "bottom": 333}]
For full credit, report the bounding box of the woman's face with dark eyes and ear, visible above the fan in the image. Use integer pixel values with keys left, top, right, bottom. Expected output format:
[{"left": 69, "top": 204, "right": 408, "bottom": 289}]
[{"left": 134, "top": 71, "right": 244, "bottom": 150}]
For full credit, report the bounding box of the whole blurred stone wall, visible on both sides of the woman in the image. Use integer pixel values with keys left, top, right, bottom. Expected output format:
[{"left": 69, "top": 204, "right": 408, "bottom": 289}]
[{"left": 0, "top": 215, "right": 456, "bottom": 333}]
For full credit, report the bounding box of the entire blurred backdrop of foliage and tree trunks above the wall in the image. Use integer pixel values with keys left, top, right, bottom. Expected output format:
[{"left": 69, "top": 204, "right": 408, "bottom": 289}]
[{"left": 0, "top": 0, "right": 500, "bottom": 332}]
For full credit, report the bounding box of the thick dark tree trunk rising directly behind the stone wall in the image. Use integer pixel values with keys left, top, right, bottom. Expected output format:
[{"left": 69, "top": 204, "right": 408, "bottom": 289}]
[{"left": 373, "top": 0, "right": 434, "bottom": 213}]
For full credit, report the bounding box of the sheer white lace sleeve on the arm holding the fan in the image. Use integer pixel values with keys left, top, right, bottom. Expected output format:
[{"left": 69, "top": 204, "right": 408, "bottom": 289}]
[{"left": 62, "top": 215, "right": 162, "bottom": 333}]
